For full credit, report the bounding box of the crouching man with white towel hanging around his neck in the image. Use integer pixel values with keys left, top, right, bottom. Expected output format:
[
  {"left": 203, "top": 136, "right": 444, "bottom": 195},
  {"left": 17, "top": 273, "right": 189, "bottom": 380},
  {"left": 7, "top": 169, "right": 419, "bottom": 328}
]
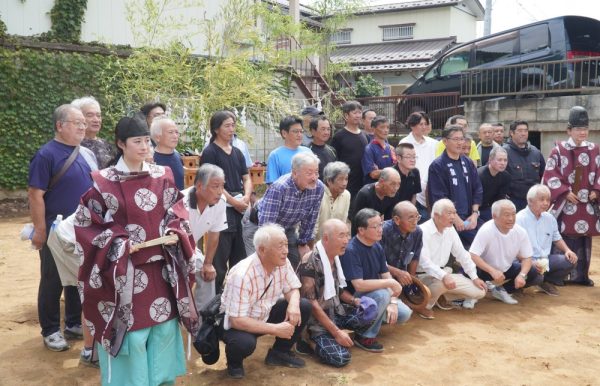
[{"left": 298, "top": 219, "right": 377, "bottom": 367}]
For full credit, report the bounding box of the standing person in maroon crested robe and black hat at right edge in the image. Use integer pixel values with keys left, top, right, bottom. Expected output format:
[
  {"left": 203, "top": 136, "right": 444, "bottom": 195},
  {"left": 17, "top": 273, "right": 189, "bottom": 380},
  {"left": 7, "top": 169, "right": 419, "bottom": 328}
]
[{"left": 543, "top": 106, "right": 600, "bottom": 287}]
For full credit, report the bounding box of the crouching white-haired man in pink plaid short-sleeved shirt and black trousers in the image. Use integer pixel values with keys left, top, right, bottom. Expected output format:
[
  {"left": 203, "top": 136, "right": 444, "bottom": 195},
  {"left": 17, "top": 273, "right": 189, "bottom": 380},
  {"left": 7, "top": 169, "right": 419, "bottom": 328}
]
[{"left": 220, "top": 224, "right": 312, "bottom": 379}]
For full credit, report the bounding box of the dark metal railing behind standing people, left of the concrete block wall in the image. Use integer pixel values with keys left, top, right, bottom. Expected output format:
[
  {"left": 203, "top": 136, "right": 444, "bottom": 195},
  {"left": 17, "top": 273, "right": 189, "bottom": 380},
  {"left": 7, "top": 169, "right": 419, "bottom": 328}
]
[{"left": 357, "top": 92, "right": 464, "bottom": 135}]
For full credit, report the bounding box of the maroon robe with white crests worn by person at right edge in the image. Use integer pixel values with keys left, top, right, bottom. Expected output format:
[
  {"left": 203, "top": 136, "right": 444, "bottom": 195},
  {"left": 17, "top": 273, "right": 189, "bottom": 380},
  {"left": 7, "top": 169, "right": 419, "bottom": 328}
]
[{"left": 543, "top": 139, "right": 600, "bottom": 236}]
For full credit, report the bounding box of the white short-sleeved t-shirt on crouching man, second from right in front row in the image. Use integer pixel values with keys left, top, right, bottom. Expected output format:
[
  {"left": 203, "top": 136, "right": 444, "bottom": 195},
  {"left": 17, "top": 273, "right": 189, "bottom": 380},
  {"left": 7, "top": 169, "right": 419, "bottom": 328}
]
[{"left": 469, "top": 220, "right": 533, "bottom": 272}]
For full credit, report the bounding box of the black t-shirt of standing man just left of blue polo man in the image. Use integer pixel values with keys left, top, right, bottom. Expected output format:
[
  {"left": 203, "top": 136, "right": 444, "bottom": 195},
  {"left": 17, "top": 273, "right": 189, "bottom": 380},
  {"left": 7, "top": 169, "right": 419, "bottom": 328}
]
[{"left": 331, "top": 129, "right": 369, "bottom": 198}]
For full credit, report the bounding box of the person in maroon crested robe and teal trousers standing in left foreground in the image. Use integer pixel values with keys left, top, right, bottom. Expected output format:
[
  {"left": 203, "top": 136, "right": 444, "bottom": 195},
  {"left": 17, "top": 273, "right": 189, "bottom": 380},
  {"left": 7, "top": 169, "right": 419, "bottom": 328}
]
[{"left": 74, "top": 117, "right": 198, "bottom": 385}]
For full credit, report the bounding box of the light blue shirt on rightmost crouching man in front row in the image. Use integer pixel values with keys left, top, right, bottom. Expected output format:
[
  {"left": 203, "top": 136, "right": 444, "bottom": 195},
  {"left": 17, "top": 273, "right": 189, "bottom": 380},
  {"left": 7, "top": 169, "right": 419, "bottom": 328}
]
[{"left": 517, "top": 206, "right": 562, "bottom": 258}]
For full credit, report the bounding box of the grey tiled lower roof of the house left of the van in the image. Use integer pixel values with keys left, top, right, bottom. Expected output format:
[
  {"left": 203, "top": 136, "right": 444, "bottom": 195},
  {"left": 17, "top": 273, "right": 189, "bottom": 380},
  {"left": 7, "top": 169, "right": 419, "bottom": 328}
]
[{"left": 331, "top": 37, "right": 456, "bottom": 71}]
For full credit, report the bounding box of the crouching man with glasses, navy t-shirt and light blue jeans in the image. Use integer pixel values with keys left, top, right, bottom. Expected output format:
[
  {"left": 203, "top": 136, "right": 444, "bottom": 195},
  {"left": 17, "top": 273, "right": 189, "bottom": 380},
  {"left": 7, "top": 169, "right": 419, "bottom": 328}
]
[{"left": 340, "top": 208, "right": 412, "bottom": 352}]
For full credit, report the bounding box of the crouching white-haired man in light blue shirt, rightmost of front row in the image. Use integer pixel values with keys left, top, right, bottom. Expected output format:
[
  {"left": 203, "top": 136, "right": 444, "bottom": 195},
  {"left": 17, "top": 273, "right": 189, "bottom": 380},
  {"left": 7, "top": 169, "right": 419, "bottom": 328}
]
[{"left": 517, "top": 184, "right": 577, "bottom": 296}]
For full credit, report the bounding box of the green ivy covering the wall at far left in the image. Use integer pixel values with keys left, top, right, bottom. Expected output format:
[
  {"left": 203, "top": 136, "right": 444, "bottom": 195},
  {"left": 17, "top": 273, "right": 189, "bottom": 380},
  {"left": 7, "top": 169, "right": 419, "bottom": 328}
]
[{"left": 0, "top": 47, "right": 122, "bottom": 189}]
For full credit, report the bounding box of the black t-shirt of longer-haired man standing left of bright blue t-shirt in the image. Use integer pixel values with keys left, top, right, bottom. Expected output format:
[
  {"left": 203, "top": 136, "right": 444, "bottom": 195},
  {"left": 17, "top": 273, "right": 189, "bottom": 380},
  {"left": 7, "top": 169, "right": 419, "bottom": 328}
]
[{"left": 200, "top": 142, "right": 248, "bottom": 232}]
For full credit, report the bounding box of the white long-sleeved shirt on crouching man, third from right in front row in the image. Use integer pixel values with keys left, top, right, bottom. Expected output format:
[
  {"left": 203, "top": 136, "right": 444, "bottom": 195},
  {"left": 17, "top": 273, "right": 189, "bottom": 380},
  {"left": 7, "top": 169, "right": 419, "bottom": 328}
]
[{"left": 418, "top": 219, "right": 477, "bottom": 280}]
